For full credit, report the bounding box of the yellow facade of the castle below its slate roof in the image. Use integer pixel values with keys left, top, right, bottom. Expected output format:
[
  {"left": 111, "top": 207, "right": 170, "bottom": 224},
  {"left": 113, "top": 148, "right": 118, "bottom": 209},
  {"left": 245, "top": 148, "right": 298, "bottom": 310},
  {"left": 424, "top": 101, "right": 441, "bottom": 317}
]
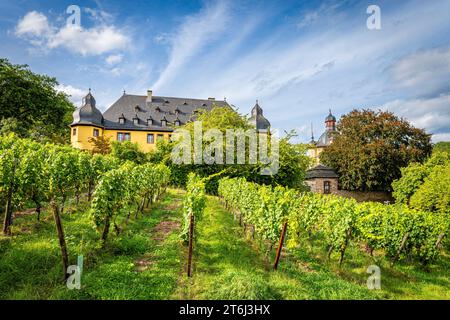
[{"left": 70, "top": 125, "right": 171, "bottom": 152}]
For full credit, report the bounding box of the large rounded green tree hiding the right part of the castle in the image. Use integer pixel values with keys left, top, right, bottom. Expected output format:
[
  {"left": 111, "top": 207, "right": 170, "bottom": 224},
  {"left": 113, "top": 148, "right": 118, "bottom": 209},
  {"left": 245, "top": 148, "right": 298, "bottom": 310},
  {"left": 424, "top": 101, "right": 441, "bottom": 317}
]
[{"left": 155, "top": 107, "right": 309, "bottom": 194}]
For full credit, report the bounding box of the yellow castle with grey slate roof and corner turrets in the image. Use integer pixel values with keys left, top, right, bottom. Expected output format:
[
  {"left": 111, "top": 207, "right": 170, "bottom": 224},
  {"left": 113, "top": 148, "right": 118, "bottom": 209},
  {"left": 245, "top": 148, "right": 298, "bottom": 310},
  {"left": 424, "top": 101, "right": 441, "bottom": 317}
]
[{"left": 70, "top": 89, "right": 270, "bottom": 152}]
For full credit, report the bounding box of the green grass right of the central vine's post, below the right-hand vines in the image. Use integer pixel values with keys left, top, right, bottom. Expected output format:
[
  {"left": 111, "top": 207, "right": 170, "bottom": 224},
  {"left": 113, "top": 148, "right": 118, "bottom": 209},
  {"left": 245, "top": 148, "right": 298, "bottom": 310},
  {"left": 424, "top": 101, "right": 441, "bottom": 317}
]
[{"left": 178, "top": 197, "right": 450, "bottom": 299}]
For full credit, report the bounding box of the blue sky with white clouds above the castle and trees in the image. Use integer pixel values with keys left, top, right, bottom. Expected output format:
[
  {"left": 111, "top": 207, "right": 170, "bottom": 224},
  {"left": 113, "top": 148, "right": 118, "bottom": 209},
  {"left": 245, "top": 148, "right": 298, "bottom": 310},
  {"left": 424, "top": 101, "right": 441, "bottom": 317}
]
[{"left": 0, "top": 0, "right": 450, "bottom": 142}]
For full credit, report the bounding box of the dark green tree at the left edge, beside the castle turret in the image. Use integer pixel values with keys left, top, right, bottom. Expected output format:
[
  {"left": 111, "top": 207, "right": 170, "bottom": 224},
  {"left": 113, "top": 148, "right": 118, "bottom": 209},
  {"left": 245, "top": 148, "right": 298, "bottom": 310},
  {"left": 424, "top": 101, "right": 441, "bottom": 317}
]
[{"left": 0, "top": 59, "right": 75, "bottom": 142}]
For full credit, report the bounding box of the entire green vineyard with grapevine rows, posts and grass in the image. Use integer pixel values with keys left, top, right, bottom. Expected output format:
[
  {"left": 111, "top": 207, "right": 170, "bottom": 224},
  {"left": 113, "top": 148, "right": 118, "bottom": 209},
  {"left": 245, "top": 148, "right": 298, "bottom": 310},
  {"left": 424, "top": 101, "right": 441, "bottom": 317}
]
[{"left": 0, "top": 136, "right": 450, "bottom": 299}]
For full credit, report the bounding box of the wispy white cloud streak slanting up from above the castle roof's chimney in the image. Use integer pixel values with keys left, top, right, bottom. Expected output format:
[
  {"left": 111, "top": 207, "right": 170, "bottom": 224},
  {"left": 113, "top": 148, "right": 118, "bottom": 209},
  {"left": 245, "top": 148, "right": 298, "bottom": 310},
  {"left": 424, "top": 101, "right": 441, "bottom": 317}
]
[{"left": 153, "top": 1, "right": 228, "bottom": 90}]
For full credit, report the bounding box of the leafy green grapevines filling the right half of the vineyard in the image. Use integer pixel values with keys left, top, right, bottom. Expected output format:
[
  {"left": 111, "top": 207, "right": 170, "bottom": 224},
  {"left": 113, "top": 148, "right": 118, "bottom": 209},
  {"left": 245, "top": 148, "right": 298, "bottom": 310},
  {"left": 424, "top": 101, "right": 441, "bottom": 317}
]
[{"left": 219, "top": 178, "right": 450, "bottom": 265}]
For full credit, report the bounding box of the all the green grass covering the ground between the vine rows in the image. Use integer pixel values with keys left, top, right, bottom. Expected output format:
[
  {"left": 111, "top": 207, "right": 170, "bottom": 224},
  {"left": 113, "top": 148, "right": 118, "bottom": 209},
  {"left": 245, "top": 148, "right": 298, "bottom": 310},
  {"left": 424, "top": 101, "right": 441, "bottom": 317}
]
[{"left": 0, "top": 190, "right": 450, "bottom": 299}]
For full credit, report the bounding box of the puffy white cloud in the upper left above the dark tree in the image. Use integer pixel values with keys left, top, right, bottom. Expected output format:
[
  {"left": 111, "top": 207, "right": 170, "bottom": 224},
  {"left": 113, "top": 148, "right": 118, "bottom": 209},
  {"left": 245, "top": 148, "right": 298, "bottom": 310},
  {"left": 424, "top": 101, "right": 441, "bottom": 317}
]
[{"left": 16, "top": 11, "right": 130, "bottom": 56}]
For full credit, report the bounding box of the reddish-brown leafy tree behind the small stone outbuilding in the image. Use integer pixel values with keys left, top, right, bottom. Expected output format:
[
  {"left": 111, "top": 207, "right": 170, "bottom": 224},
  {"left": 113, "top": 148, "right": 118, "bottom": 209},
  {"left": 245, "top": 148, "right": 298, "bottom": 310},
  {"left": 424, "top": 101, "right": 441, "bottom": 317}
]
[{"left": 320, "top": 110, "right": 432, "bottom": 191}]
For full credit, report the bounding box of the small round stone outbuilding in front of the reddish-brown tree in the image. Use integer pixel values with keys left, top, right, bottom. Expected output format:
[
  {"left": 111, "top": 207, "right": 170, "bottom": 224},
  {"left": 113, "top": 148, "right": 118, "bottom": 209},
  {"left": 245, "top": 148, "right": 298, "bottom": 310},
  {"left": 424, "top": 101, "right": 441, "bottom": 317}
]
[{"left": 305, "top": 164, "right": 338, "bottom": 194}]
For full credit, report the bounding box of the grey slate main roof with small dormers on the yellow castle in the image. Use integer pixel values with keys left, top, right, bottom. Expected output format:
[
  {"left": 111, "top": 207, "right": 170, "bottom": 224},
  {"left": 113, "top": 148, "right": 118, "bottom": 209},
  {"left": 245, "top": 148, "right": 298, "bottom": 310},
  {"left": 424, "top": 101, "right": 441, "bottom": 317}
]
[{"left": 72, "top": 93, "right": 231, "bottom": 132}]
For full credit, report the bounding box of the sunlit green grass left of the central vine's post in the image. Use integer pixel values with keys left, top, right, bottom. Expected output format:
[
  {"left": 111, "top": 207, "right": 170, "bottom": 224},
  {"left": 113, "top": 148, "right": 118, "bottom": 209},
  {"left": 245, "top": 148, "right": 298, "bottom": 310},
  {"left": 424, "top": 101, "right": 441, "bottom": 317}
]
[{"left": 0, "top": 190, "right": 183, "bottom": 299}]
